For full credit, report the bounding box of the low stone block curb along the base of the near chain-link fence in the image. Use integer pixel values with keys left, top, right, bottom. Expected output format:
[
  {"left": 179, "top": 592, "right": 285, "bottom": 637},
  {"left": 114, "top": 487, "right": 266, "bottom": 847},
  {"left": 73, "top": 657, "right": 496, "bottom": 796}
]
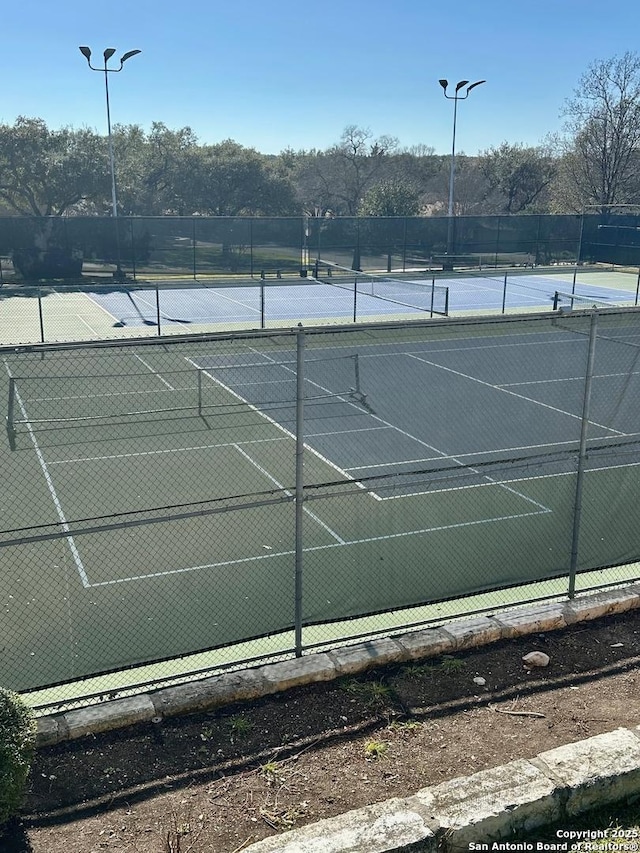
[{"left": 37, "top": 584, "right": 640, "bottom": 744}]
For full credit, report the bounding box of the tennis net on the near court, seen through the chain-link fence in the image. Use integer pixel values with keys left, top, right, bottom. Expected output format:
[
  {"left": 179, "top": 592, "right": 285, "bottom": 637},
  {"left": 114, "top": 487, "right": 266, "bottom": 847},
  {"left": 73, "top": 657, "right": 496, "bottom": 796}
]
[{"left": 5, "top": 351, "right": 366, "bottom": 450}]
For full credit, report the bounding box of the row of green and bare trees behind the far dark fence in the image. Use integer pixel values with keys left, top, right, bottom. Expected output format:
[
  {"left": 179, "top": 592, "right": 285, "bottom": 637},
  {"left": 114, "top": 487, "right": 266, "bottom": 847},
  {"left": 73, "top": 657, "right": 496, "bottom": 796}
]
[{"left": 0, "top": 52, "right": 640, "bottom": 217}]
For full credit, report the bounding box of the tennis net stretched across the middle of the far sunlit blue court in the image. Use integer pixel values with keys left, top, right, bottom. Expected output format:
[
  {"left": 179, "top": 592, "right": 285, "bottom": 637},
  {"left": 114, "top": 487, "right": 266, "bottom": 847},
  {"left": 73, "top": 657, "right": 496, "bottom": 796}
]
[{"left": 313, "top": 260, "right": 449, "bottom": 320}]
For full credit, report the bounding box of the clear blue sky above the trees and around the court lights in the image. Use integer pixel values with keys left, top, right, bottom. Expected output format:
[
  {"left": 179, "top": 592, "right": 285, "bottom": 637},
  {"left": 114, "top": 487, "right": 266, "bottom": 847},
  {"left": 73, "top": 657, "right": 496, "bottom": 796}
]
[{"left": 0, "top": 0, "right": 640, "bottom": 154}]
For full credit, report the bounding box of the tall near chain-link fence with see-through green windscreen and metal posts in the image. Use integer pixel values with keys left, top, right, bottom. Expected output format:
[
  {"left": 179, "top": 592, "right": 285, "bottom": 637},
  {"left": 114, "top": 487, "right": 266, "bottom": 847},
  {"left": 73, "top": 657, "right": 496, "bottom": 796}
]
[{"left": 0, "top": 308, "right": 640, "bottom": 708}]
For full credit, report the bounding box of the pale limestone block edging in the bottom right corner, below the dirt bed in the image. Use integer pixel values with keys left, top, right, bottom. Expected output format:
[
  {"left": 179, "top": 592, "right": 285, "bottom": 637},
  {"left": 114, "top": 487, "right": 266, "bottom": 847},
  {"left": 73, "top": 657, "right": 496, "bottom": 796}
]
[{"left": 244, "top": 726, "right": 640, "bottom": 853}]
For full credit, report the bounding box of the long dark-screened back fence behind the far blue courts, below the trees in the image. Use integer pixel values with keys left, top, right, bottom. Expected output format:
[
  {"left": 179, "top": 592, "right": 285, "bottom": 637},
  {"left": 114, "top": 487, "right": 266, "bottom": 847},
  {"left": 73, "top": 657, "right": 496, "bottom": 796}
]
[{"left": 0, "top": 215, "right": 586, "bottom": 281}]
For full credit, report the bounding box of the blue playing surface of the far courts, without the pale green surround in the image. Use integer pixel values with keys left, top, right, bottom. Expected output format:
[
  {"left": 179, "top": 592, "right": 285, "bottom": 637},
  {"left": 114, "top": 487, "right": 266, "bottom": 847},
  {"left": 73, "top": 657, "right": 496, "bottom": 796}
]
[{"left": 84, "top": 271, "right": 635, "bottom": 331}]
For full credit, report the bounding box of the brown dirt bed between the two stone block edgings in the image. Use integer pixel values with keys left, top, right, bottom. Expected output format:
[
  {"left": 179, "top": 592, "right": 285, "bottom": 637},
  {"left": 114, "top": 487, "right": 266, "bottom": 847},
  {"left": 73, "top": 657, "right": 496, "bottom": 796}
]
[{"left": 3, "top": 611, "right": 640, "bottom": 853}]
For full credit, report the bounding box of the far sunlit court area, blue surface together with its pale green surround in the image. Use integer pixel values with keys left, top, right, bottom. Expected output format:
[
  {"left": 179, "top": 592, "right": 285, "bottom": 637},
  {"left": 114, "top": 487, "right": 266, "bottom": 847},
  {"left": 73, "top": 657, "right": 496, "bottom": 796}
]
[{"left": 0, "top": 262, "right": 638, "bottom": 344}]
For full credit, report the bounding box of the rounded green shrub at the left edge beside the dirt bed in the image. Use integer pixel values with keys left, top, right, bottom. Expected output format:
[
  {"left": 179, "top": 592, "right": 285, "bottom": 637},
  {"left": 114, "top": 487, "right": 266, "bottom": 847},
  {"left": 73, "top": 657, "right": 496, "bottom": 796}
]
[{"left": 0, "top": 688, "right": 36, "bottom": 828}]
